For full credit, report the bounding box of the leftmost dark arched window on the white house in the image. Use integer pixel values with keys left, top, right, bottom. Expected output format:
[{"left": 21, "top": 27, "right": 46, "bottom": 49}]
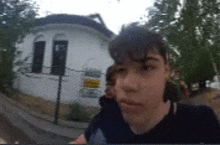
[{"left": 32, "top": 35, "right": 46, "bottom": 73}]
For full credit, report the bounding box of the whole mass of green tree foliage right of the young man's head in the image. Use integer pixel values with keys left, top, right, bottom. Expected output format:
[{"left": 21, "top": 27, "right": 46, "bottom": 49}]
[{"left": 147, "top": 0, "right": 220, "bottom": 85}]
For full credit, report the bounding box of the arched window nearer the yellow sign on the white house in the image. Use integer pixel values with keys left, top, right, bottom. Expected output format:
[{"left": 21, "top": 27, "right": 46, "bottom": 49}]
[{"left": 51, "top": 34, "right": 68, "bottom": 75}]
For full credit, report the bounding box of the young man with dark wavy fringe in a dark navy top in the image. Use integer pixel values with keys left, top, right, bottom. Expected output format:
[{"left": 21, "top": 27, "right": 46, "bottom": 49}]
[{"left": 69, "top": 25, "right": 220, "bottom": 144}]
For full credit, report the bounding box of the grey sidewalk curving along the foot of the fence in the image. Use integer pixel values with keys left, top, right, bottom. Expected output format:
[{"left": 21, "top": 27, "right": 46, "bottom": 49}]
[{"left": 0, "top": 93, "right": 88, "bottom": 142}]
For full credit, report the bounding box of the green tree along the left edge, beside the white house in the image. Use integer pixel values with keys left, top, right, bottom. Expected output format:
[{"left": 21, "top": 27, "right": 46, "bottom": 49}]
[{"left": 0, "top": 0, "right": 37, "bottom": 91}]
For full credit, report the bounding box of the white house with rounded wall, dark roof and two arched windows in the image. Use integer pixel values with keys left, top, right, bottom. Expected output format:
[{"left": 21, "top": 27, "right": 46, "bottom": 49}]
[{"left": 14, "top": 14, "right": 114, "bottom": 106}]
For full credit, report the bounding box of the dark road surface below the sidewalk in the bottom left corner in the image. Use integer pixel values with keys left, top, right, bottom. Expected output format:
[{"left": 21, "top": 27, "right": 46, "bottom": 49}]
[{"left": 0, "top": 114, "right": 72, "bottom": 144}]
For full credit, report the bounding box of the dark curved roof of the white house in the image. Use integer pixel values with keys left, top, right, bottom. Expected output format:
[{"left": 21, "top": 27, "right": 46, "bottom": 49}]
[{"left": 38, "top": 14, "right": 114, "bottom": 38}]
